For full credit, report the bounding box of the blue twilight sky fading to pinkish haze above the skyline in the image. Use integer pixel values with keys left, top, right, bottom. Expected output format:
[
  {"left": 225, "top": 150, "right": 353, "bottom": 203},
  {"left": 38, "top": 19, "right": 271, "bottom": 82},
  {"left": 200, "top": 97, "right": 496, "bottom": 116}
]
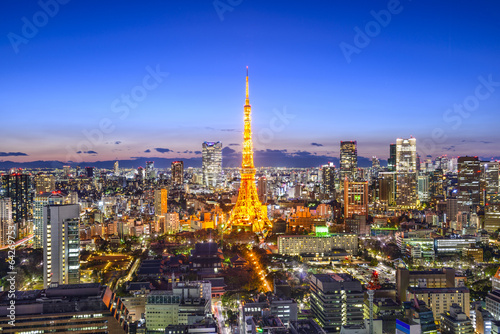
[{"left": 0, "top": 0, "right": 500, "bottom": 166}]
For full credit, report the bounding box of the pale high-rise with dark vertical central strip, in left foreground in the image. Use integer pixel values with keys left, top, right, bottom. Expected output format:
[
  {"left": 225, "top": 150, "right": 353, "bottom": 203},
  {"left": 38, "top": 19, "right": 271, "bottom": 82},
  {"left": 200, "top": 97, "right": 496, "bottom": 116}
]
[{"left": 43, "top": 204, "right": 80, "bottom": 288}]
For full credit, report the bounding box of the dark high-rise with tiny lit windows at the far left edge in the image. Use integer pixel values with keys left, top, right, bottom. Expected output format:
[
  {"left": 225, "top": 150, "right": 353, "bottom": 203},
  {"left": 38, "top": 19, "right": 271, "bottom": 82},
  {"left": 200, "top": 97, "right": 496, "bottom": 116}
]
[{"left": 2, "top": 173, "right": 31, "bottom": 223}]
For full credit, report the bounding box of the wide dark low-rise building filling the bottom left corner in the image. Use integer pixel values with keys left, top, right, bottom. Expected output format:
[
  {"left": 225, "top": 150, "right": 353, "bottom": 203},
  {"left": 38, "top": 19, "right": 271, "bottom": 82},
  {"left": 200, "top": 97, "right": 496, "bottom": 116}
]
[{"left": 0, "top": 283, "right": 128, "bottom": 334}]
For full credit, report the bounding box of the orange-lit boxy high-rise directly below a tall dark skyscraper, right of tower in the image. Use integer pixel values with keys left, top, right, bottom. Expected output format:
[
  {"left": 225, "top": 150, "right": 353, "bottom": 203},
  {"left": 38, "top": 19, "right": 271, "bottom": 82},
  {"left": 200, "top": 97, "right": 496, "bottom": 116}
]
[{"left": 344, "top": 179, "right": 368, "bottom": 219}]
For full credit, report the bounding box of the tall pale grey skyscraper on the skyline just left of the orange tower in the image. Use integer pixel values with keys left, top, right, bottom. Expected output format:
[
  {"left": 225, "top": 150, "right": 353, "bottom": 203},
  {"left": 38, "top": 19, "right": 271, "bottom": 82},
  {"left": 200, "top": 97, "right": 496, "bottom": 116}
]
[{"left": 201, "top": 141, "right": 222, "bottom": 188}]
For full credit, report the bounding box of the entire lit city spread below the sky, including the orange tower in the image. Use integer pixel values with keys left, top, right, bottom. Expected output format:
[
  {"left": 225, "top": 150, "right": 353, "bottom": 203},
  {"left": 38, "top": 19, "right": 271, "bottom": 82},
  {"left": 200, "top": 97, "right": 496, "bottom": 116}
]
[{"left": 0, "top": 68, "right": 500, "bottom": 334}]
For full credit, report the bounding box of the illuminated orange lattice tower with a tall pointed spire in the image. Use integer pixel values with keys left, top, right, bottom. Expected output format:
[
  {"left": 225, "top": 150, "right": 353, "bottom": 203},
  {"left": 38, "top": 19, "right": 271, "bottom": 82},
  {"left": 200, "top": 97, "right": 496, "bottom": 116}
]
[{"left": 225, "top": 66, "right": 272, "bottom": 236}]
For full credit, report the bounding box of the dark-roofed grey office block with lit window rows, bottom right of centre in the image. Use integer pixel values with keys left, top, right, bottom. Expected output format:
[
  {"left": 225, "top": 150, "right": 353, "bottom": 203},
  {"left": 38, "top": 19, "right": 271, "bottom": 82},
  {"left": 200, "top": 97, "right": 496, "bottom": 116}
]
[{"left": 310, "top": 274, "right": 364, "bottom": 333}]
